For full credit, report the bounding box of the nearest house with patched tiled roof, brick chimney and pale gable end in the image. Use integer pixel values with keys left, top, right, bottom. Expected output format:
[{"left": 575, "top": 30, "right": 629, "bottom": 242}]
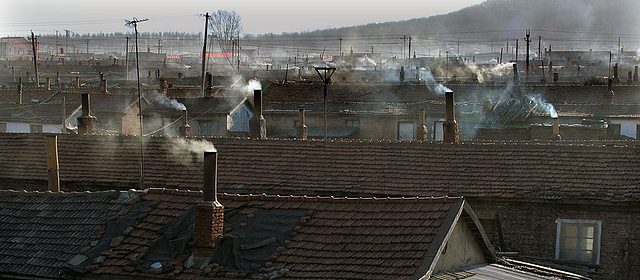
[{"left": 0, "top": 185, "right": 588, "bottom": 279}]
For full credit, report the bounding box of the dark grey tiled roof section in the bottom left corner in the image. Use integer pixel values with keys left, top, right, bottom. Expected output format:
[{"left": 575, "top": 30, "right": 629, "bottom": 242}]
[{"left": 0, "top": 191, "right": 128, "bottom": 279}]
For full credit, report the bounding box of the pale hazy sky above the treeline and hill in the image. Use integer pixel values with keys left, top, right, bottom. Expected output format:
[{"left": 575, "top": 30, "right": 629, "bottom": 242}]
[{"left": 0, "top": 0, "right": 483, "bottom": 37}]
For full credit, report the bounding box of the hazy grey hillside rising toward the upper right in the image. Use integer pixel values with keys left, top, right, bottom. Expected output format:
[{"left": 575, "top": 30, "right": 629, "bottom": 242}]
[{"left": 251, "top": 0, "right": 640, "bottom": 52}]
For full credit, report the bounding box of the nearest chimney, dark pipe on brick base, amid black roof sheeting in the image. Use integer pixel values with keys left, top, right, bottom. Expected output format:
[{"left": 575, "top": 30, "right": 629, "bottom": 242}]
[{"left": 192, "top": 151, "right": 224, "bottom": 257}]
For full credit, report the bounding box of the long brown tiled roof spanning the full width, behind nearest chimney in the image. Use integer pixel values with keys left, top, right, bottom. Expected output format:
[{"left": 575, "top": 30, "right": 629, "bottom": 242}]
[{"left": 0, "top": 134, "right": 640, "bottom": 201}]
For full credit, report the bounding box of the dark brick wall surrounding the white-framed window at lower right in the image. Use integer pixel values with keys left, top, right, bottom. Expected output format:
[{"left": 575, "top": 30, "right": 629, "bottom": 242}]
[{"left": 469, "top": 199, "right": 640, "bottom": 280}]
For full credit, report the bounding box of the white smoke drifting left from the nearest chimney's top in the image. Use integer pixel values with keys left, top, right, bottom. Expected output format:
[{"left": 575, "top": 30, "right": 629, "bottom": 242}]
[{"left": 169, "top": 137, "right": 217, "bottom": 165}]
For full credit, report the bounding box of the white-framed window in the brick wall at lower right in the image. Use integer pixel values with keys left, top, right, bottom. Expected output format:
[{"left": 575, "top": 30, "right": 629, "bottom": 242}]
[{"left": 556, "top": 219, "right": 602, "bottom": 264}]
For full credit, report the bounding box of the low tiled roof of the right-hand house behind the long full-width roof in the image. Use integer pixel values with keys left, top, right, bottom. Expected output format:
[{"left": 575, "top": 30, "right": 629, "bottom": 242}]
[{"left": 263, "top": 81, "right": 640, "bottom": 104}]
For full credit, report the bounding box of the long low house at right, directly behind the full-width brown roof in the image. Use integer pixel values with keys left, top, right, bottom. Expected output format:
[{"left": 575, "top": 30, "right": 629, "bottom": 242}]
[{"left": 264, "top": 82, "right": 640, "bottom": 141}]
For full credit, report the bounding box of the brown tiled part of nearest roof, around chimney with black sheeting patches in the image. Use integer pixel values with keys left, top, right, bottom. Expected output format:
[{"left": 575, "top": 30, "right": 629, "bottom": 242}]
[{"left": 84, "top": 189, "right": 470, "bottom": 279}]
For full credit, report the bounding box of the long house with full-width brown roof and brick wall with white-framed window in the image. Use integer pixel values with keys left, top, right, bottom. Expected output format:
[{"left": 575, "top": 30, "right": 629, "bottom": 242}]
[{"left": 0, "top": 134, "right": 640, "bottom": 279}]
